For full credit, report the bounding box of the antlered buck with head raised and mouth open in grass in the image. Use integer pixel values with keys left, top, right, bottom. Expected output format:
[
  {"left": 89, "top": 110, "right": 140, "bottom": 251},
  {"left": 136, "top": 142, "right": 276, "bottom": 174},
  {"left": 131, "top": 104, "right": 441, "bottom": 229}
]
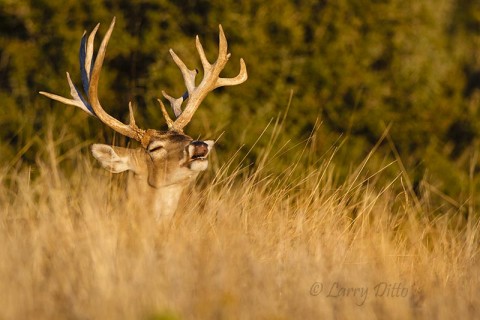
[{"left": 40, "top": 18, "right": 247, "bottom": 219}]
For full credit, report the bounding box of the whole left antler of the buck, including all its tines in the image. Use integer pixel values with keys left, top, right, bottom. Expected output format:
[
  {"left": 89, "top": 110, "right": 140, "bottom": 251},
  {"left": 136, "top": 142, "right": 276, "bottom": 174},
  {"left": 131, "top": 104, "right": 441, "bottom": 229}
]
[{"left": 40, "top": 18, "right": 148, "bottom": 145}]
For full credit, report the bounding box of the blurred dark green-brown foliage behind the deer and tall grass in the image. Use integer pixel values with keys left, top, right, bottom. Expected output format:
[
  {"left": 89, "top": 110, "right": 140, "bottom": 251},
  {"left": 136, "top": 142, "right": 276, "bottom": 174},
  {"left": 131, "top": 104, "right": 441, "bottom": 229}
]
[{"left": 0, "top": 0, "right": 480, "bottom": 208}]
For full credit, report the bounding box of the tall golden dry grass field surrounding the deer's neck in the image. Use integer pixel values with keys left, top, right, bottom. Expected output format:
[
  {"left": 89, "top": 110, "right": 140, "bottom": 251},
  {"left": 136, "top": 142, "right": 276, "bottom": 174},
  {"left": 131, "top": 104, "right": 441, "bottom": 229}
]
[{"left": 0, "top": 125, "right": 480, "bottom": 319}]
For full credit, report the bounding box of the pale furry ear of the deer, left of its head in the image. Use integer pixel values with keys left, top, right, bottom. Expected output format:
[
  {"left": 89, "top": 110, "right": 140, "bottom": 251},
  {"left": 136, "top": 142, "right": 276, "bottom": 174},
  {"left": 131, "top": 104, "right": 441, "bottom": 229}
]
[{"left": 91, "top": 144, "right": 133, "bottom": 173}]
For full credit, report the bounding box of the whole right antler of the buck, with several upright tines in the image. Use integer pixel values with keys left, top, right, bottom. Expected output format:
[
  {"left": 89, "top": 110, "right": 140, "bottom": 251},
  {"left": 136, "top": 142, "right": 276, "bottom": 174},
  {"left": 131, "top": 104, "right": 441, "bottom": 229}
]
[{"left": 163, "top": 25, "right": 248, "bottom": 132}]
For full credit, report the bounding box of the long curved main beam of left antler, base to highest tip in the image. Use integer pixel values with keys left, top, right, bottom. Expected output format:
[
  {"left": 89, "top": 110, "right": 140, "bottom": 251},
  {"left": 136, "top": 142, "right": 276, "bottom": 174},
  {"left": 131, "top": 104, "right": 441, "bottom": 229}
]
[{"left": 88, "top": 18, "right": 145, "bottom": 142}]
